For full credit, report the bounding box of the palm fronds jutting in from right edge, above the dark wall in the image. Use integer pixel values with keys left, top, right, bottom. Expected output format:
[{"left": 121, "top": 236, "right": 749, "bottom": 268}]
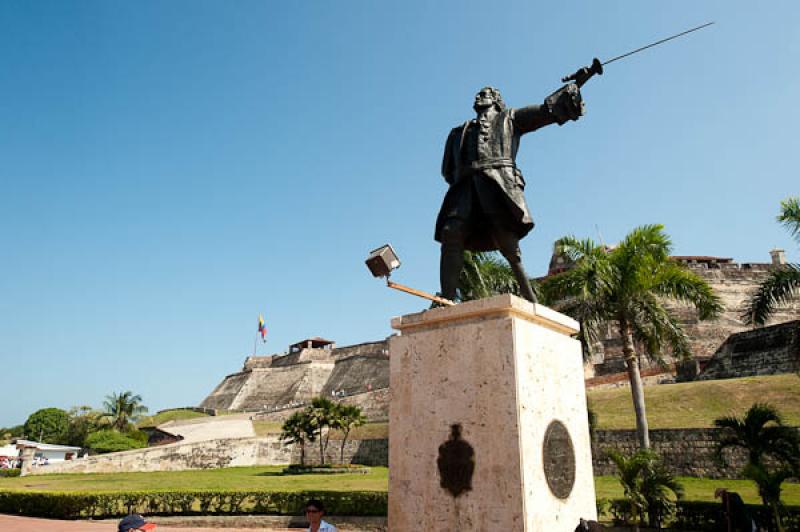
[{"left": 742, "top": 197, "right": 800, "bottom": 325}]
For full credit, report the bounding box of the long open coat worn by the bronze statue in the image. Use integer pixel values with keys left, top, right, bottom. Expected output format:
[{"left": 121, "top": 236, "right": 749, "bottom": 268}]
[{"left": 435, "top": 105, "right": 556, "bottom": 251}]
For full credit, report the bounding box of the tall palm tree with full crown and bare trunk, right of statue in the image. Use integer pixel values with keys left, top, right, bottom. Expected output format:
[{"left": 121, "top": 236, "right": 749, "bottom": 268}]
[{"left": 543, "top": 225, "right": 722, "bottom": 449}]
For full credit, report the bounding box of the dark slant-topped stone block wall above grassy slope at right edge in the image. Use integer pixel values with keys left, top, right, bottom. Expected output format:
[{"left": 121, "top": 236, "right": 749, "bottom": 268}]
[{"left": 697, "top": 320, "right": 800, "bottom": 380}]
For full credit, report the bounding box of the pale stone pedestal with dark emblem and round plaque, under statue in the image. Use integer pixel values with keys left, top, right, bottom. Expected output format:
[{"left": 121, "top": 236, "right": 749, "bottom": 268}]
[{"left": 389, "top": 295, "right": 596, "bottom": 532}]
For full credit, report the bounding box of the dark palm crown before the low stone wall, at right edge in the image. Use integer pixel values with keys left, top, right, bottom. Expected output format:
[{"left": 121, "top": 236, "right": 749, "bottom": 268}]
[{"left": 714, "top": 403, "right": 800, "bottom": 469}]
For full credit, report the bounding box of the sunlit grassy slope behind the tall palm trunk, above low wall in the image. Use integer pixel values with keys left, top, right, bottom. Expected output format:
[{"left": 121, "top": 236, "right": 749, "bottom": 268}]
[{"left": 588, "top": 374, "right": 800, "bottom": 429}]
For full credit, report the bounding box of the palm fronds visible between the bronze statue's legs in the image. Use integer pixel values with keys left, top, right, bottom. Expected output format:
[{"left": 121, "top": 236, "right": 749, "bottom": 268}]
[{"left": 458, "top": 251, "right": 520, "bottom": 301}]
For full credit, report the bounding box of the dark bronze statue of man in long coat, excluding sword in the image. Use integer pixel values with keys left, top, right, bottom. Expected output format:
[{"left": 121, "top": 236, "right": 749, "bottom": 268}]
[{"left": 435, "top": 83, "right": 583, "bottom": 302}]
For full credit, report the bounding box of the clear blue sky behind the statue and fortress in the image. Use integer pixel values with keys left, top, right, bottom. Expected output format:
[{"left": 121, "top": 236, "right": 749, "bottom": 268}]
[{"left": 0, "top": 0, "right": 800, "bottom": 425}]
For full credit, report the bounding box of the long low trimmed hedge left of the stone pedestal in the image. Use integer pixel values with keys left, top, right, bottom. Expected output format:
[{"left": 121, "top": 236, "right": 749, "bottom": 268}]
[{"left": 0, "top": 490, "right": 388, "bottom": 519}]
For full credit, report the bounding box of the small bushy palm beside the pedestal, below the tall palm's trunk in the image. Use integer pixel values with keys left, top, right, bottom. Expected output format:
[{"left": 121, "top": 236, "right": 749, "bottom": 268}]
[{"left": 608, "top": 449, "right": 683, "bottom": 530}]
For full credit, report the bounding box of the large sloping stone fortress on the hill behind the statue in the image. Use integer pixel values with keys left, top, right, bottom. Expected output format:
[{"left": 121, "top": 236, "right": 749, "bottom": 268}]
[{"left": 199, "top": 250, "right": 800, "bottom": 420}]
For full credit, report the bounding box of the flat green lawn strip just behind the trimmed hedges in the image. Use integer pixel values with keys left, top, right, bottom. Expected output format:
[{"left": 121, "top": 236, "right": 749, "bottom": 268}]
[{"left": 0, "top": 466, "right": 800, "bottom": 506}]
